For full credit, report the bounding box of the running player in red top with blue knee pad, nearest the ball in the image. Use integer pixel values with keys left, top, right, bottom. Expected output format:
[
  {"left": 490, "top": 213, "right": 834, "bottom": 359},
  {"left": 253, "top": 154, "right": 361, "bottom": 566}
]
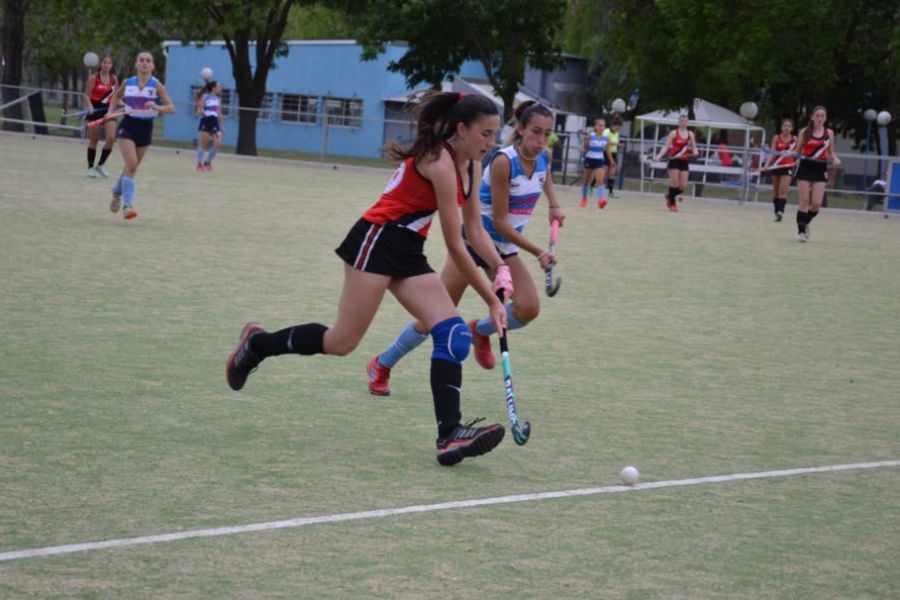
[{"left": 226, "top": 93, "right": 513, "bottom": 466}]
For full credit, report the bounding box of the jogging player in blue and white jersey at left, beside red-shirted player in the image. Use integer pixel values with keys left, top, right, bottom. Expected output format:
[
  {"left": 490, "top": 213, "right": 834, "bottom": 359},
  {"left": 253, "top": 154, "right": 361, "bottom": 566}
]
[{"left": 109, "top": 51, "right": 175, "bottom": 220}]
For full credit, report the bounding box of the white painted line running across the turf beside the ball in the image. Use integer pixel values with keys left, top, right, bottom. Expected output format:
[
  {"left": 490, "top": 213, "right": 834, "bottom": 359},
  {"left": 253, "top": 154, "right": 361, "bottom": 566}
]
[{"left": 0, "top": 460, "right": 900, "bottom": 562}]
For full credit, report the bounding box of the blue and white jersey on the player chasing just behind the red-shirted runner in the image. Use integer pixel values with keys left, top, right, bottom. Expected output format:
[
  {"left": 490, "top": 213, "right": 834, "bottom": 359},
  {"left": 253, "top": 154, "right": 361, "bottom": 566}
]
[{"left": 478, "top": 146, "right": 549, "bottom": 255}]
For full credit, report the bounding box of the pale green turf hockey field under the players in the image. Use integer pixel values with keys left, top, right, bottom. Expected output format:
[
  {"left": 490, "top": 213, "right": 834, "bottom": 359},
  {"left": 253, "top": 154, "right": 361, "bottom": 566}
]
[{"left": 0, "top": 135, "right": 900, "bottom": 600}]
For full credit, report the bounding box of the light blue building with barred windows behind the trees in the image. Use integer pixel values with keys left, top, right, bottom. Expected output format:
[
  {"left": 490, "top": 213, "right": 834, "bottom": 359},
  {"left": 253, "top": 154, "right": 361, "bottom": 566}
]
[{"left": 163, "top": 40, "right": 592, "bottom": 158}]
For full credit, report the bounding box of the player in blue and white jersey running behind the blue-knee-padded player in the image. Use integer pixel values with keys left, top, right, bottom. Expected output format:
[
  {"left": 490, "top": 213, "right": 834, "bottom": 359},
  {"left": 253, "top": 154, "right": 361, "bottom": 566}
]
[{"left": 366, "top": 101, "right": 566, "bottom": 396}]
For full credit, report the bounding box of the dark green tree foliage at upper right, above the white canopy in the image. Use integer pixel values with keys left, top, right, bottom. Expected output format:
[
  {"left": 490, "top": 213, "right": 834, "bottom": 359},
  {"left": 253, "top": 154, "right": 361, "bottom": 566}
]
[{"left": 572, "top": 0, "right": 900, "bottom": 149}]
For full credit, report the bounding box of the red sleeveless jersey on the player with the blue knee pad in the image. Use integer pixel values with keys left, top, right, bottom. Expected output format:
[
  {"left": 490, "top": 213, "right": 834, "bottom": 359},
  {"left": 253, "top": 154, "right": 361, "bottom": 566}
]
[{"left": 363, "top": 146, "right": 472, "bottom": 238}]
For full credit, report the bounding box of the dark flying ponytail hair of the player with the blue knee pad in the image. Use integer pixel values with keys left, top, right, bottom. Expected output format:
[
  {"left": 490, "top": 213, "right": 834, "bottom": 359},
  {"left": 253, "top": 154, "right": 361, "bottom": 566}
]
[{"left": 386, "top": 92, "right": 500, "bottom": 161}]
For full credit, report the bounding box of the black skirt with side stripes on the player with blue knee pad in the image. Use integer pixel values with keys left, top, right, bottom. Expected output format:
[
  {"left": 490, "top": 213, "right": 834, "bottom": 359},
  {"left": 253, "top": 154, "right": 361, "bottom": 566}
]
[{"left": 334, "top": 219, "right": 434, "bottom": 278}]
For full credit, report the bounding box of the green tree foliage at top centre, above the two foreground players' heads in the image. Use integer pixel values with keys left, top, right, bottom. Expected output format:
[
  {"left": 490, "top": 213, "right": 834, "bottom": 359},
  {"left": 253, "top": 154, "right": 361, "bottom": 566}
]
[{"left": 357, "top": 0, "right": 567, "bottom": 120}]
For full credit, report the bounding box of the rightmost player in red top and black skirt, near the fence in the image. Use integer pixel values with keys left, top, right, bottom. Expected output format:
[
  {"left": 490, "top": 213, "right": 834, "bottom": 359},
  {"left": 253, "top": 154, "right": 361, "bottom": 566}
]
[{"left": 797, "top": 106, "right": 841, "bottom": 242}]
